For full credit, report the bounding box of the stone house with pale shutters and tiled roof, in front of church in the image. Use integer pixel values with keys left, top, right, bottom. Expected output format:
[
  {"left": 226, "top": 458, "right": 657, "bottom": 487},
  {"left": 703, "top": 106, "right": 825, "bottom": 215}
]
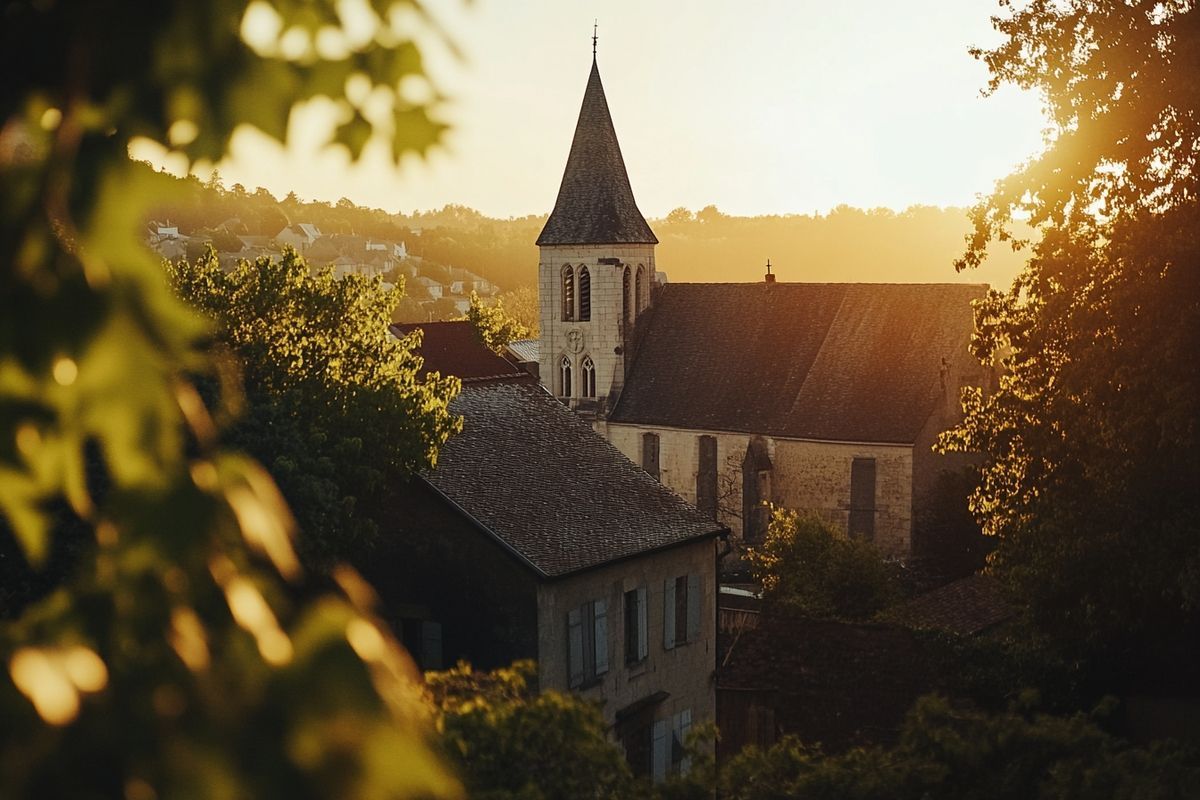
[{"left": 379, "top": 321, "right": 726, "bottom": 778}]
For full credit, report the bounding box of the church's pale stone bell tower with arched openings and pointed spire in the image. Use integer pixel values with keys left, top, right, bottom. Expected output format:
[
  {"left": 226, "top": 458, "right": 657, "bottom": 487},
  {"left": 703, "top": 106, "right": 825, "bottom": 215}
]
[{"left": 538, "top": 43, "right": 659, "bottom": 416}]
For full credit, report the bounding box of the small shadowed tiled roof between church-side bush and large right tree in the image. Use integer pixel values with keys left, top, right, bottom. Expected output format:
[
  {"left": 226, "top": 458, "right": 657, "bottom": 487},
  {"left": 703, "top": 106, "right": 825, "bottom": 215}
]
[{"left": 881, "top": 575, "right": 1014, "bottom": 636}]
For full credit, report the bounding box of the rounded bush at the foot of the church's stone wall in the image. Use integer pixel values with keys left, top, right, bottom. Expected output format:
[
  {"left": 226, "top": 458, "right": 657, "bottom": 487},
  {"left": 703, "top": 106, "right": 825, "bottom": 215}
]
[{"left": 746, "top": 509, "right": 902, "bottom": 619}]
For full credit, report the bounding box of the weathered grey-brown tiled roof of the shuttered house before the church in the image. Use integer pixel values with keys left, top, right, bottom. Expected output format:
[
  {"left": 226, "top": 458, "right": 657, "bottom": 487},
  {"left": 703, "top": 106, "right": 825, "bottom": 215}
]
[{"left": 425, "top": 381, "right": 722, "bottom": 577}]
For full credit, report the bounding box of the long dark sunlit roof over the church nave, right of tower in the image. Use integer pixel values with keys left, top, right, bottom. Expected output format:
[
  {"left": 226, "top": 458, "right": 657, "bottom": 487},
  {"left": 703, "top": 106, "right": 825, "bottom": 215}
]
[{"left": 611, "top": 283, "right": 986, "bottom": 444}]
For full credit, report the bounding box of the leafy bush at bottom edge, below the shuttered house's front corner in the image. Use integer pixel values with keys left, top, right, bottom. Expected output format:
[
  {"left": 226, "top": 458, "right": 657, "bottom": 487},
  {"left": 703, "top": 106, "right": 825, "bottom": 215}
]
[{"left": 426, "top": 661, "right": 634, "bottom": 800}]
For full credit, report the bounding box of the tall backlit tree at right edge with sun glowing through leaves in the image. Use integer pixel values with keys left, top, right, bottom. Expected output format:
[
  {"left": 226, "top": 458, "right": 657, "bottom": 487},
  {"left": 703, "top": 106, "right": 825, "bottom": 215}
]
[{"left": 942, "top": 0, "right": 1200, "bottom": 671}]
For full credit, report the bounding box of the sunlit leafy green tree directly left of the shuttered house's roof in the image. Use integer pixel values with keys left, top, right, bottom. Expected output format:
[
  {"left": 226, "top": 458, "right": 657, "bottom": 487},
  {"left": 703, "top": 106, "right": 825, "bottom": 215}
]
[{"left": 168, "top": 248, "right": 462, "bottom": 571}]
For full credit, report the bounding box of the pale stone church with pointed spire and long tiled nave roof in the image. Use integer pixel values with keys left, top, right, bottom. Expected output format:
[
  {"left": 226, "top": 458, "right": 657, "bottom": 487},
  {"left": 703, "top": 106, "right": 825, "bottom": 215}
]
[{"left": 524, "top": 54, "right": 992, "bottom": 559}]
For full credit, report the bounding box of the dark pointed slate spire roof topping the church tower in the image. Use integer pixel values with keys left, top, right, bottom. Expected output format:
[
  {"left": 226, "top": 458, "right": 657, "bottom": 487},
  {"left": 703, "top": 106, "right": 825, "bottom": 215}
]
[{"left": 538, "top": 59, "right": 659, "bottom": 246}]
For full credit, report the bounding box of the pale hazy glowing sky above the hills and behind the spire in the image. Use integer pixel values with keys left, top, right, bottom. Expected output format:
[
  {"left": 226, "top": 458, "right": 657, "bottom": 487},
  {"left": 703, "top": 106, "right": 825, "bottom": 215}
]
[{"left": 157, "top": 0, "right": 1043, "bottom": 217}]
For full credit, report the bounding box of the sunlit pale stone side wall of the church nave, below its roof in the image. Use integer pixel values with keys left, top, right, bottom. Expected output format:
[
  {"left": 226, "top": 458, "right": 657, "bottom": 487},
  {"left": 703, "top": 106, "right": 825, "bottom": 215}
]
[{"left": 605, "top": 421, "right": 913, "bottom": 558}]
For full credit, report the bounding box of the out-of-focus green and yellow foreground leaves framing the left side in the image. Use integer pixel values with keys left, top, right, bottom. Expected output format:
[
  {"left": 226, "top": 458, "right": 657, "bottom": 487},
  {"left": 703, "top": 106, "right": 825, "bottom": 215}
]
[{"left": 0, "top": 0, "right": 458, "bottom": 798}]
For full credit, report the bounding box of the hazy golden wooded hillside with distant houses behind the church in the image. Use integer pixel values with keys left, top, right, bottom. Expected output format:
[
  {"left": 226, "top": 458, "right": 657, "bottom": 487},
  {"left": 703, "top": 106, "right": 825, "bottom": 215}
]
[{"left": 154, "top": 178, "right": 1024, "bottom": 298}]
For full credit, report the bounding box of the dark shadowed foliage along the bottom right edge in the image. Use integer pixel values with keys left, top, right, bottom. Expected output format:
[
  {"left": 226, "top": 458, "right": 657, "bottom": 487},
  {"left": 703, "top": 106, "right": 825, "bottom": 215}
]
[{"left": 710, "top": 696, "right": 1200, "bottom": 800}]
